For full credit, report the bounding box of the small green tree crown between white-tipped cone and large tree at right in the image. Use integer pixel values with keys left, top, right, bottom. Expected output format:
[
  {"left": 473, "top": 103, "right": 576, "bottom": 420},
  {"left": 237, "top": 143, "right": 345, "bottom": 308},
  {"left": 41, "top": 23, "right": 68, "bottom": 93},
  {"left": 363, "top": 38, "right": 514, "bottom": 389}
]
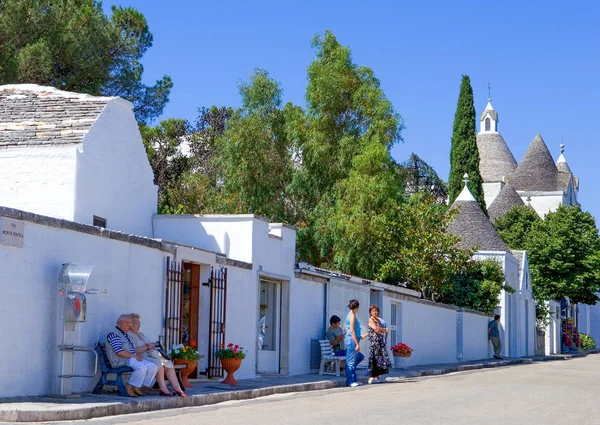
[{"left": 495, "top": 205, "right": 542, "bottom": 250}]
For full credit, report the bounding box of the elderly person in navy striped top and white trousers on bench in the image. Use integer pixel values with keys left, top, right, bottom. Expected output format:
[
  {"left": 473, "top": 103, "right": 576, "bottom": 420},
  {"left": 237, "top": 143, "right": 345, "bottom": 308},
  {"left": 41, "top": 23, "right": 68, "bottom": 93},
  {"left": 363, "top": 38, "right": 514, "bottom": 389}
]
[{"left": 106, "top": 314, "right": 158, "bottom": 397}]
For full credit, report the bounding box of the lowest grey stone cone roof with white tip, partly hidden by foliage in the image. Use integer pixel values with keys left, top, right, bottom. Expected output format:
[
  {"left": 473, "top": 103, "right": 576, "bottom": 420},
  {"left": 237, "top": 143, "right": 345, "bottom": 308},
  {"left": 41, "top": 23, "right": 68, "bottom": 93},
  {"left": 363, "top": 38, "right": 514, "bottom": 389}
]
[{"left": 448, "top": 185, "right": 509, "bottom": 252}]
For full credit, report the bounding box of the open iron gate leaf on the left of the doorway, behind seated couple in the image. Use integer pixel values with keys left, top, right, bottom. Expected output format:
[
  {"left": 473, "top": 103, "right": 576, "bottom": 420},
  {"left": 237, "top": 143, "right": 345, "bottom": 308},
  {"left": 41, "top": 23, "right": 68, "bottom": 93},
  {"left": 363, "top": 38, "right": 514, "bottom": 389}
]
[{"left": 164, "top": 257, "right": 183, "bottom": 351}]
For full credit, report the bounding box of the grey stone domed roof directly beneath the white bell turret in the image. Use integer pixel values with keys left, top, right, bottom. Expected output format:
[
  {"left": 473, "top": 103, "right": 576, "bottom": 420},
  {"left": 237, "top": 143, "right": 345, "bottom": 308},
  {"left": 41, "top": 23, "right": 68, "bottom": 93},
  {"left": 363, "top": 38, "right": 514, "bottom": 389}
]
[{"left": 477, "top": 133, "right": 517, "bottom": 182}]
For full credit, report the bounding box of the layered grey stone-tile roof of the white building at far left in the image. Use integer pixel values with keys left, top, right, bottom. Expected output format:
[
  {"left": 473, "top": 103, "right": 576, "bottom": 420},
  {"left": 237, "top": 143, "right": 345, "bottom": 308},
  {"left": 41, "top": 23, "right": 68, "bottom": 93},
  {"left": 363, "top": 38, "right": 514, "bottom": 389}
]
[{"left": 0, "top": 84, "right": 115, "bottom": 148}]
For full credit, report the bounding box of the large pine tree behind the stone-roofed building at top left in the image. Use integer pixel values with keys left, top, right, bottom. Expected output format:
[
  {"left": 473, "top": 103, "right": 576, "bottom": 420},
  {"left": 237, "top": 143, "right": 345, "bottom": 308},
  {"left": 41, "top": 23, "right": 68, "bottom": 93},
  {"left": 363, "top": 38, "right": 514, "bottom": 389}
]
[{"left": 0, "top": 0, "right": 173, "bottom": 122}]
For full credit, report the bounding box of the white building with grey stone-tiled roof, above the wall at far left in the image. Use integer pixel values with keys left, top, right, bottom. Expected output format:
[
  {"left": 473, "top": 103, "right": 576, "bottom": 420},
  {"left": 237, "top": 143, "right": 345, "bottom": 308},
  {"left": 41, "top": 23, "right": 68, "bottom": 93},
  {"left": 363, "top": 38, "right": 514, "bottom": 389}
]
[{"left": 0, "top": 84, "right": 157, "bottom": 236}]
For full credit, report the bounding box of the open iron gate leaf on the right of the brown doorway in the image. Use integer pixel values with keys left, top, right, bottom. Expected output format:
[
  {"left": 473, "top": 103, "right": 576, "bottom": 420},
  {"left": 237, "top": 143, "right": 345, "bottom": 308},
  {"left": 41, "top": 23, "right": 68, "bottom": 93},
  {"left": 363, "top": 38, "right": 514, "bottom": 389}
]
[{"left": 208, "top": 268, "right": 227, "bottom": 378}]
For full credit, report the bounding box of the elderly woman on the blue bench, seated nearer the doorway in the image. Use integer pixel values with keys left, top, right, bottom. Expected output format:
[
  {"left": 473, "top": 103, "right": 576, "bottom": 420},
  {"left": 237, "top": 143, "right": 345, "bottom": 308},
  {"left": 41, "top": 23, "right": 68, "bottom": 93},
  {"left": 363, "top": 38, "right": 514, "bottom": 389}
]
[{"left": 128, "top": 313, "right": 186, "bottom": 397}]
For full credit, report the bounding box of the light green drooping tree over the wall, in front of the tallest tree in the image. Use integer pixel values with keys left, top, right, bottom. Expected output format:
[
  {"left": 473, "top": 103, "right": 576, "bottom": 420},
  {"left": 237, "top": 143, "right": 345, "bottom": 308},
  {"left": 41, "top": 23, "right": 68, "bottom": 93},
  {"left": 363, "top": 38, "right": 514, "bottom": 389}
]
[{"left": 314, "top": 143, "right": 404, "bottom": 279}]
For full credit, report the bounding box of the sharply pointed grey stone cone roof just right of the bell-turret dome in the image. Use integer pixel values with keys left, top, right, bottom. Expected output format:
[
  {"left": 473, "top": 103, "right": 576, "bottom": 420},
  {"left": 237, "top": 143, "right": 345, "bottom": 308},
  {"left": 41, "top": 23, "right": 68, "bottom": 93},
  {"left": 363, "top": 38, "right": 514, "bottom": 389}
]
[{"left": 509, "top": 133, "right": 563, "bottom": 192}]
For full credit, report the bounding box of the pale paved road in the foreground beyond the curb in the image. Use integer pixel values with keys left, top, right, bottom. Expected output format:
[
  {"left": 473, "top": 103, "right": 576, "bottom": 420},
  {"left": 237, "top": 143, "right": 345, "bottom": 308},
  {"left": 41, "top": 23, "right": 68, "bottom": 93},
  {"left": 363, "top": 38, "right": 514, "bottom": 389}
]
[{"left": 29, "top": 355, "right": 600, "bottom": 425}]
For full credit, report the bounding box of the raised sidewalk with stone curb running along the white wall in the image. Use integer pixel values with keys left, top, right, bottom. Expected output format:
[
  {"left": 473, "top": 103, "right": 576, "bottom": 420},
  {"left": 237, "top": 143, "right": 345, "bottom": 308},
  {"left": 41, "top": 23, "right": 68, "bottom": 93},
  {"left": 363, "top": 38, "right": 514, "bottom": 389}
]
[{"left": 0, "top": 350, "right": 600, "bottom": 422}]
